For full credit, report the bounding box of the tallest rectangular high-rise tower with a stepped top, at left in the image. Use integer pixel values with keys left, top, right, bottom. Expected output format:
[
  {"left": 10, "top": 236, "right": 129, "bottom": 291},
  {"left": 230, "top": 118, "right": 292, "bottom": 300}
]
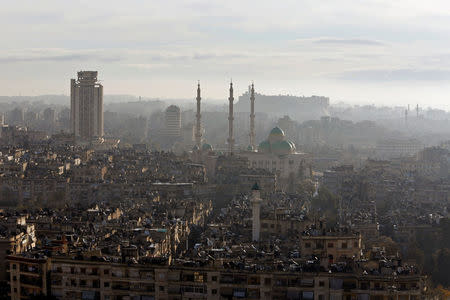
[{"left": 70, "top": 71, "right": 103, "bottom": 140}]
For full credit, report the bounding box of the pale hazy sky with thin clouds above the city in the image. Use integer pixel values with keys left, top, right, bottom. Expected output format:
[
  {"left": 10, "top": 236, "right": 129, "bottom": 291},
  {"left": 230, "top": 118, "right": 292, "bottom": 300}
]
[{"left": 0, "top": 0, "right": 450, "bottom": 109}]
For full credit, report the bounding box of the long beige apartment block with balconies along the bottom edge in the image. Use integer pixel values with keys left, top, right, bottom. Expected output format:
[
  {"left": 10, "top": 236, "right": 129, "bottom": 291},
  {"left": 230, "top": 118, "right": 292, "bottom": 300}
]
[{"left": 8, "top": 257, "right": 425, "bottom": 300}]
